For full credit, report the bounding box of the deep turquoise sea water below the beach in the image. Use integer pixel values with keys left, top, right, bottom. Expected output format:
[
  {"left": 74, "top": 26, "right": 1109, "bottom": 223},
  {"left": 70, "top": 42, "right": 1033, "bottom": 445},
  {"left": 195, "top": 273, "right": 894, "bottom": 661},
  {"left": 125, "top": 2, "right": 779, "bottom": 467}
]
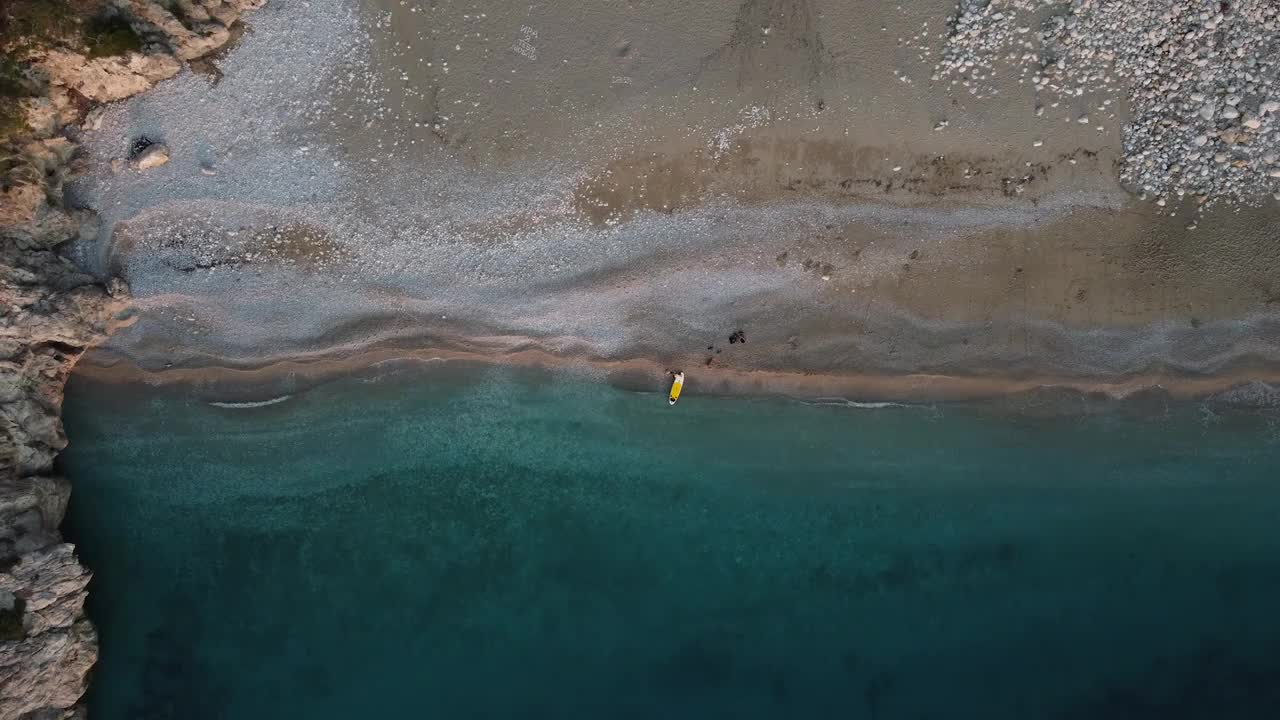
[{"left": 63, "top": 366, "right": 1280, "bottom": 720}]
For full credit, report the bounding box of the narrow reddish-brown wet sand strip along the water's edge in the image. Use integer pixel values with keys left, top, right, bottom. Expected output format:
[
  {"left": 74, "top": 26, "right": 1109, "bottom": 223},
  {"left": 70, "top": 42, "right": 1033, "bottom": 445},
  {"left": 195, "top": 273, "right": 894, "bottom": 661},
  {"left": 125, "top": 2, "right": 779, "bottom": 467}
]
[{"left": 74, "top": 338, "right": 1280, "bottom": 406}]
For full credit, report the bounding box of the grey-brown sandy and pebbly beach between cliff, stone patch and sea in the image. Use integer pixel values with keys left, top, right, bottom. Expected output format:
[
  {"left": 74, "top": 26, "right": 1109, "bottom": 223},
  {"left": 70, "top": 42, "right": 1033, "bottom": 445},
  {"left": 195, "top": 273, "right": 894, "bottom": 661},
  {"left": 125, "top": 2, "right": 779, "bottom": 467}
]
[{"left": 67, "top": 0, "right": 1280, "bottom": 398}]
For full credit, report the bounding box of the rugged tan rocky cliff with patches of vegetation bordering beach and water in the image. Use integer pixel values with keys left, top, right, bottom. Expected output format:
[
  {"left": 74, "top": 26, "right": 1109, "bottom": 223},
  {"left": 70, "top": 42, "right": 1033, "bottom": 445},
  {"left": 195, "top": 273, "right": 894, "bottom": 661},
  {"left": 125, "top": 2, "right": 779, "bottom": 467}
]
[{"left": 0, "top": 0, "right": 265, "bottom": 720}]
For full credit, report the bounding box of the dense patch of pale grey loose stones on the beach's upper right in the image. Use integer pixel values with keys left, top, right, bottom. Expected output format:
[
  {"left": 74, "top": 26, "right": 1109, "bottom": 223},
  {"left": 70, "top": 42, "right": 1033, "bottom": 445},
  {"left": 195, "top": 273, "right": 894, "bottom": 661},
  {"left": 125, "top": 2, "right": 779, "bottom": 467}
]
[{"left": 931, "top": 0, "right": 1280, "bottom": 205}]
